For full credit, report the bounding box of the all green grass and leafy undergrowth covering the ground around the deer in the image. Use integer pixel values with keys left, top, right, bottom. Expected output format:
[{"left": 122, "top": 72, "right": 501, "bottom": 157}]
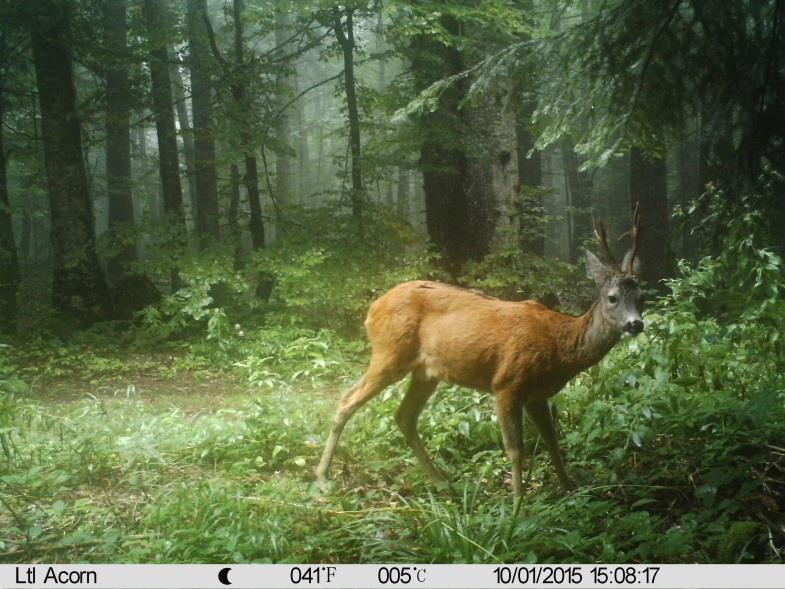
[{"left": 0, "top": 196, "right": 785, "bottom": 563}]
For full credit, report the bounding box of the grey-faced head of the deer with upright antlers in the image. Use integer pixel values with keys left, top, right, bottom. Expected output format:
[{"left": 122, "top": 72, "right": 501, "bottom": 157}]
[{"left": 586, "top": 205, "right": 643, "bottom": 335}]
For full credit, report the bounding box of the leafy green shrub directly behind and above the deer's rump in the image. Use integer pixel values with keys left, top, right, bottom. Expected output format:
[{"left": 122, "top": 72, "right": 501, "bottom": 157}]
[{"left": 255, "top": 207, "right": 435, "bottom": 336}]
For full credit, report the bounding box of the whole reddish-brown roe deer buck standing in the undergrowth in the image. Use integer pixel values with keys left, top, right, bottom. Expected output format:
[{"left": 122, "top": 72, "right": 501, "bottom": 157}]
[{"left": 316, "top": 207, "right": 643, "bottom": 496}]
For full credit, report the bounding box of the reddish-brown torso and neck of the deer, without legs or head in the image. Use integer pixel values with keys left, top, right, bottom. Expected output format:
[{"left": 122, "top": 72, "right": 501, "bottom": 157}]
[{"left": 365, "top": 281, "right": 613, "bottom": 403}]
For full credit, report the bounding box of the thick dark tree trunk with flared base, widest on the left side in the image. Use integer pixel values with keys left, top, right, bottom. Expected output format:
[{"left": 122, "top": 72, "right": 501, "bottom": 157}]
[{"left": 30, "top": 0, "right": 111, "bottom": 322}]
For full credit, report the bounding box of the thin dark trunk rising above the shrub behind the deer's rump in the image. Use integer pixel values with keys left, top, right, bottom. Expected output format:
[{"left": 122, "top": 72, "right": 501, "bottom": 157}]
[{"left": 333, "top": 7, "right": 365, "bottom": 227}]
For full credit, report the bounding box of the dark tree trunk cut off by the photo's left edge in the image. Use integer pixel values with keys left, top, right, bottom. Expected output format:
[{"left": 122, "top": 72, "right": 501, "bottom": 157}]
[{"left": 0, "top": 90, "right": 19, "bottom": 333}]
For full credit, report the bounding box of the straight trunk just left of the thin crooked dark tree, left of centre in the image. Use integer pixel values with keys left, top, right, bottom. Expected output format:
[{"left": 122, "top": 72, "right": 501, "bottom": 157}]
[{"left": 187, "top": 0, "right": 220, "bottom": 246}]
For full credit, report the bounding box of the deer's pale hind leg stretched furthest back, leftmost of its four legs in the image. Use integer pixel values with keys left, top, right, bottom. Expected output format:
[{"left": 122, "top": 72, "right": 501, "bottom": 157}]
[{"left": 316, "top": 358, "right": 406, "bottom": 490}]
